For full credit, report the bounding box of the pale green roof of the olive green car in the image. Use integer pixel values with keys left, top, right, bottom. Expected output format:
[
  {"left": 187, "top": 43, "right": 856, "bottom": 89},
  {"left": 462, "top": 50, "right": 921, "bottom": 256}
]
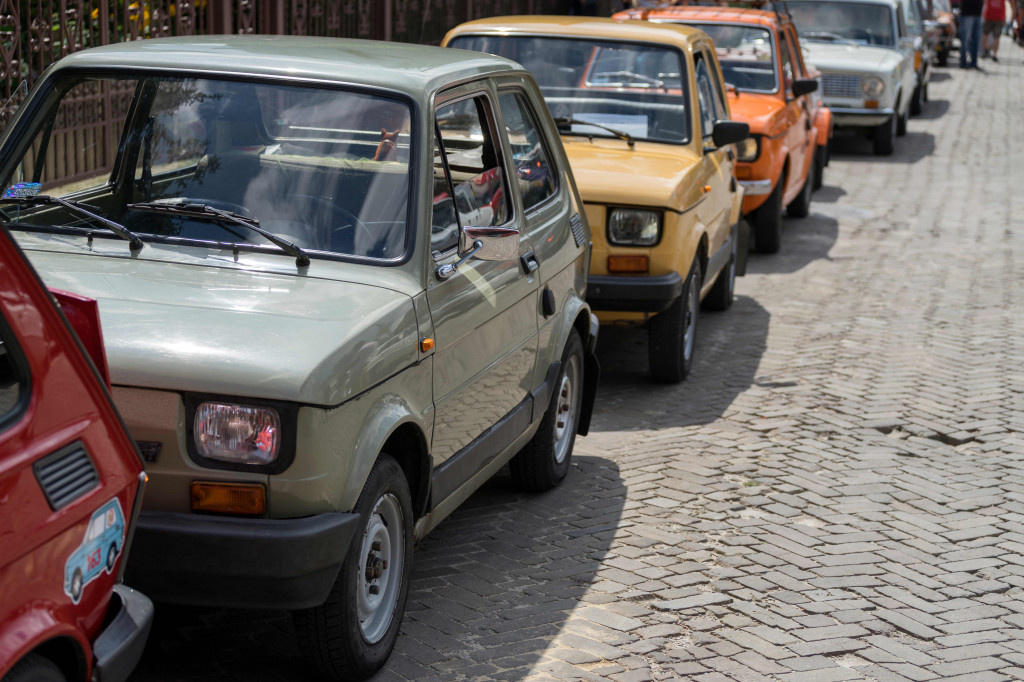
[{"left": 50, "top": 36, "right": 523, "bottom": 96}]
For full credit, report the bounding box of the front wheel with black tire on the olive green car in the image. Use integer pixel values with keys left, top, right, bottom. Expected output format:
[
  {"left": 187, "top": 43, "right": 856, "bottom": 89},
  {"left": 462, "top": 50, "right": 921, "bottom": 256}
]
[{"left": 293, "top": 453, "right": 413, "bottom": 680}]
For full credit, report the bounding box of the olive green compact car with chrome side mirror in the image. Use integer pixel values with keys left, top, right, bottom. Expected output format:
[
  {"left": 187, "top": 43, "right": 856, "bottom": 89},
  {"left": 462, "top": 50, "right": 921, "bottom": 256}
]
[{"left": 0, "top": 36, "right": 598, "bottom": 679}]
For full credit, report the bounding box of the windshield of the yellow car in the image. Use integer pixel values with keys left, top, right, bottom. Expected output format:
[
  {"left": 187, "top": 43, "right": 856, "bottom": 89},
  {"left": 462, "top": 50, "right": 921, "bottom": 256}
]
[{"left": 450, "top": 36, "right": 690, "bottom": 143}]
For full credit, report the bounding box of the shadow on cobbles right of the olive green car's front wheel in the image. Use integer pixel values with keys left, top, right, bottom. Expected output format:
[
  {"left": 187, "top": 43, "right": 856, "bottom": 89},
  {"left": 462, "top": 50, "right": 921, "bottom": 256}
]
[{"left": 395, "top": 456, "right": 627, "bottom": 680}]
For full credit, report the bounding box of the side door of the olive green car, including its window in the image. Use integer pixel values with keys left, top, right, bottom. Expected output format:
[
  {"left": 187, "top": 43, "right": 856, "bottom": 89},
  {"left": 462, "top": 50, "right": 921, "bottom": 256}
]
[{"left": 427, "top": 85, "right": 538, "bottom": 502}]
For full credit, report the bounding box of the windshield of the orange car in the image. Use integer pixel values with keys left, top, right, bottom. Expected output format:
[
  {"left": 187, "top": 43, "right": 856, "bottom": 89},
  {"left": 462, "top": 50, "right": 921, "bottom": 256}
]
[{"left": 688, "top": 23, "right": 778, "bottom": 92}]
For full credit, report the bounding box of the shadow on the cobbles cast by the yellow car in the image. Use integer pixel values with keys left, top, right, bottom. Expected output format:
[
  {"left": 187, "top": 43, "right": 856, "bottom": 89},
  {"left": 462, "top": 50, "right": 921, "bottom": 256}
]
[{"left": 590, "top": 290, "right": 770, "bottom": 430}]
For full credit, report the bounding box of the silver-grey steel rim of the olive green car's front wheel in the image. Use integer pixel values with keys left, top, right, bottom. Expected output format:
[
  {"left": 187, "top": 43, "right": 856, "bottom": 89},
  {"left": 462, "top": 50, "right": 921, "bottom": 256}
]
[{"left": 355, "top": 493, "right": 406, "bottom": 644}]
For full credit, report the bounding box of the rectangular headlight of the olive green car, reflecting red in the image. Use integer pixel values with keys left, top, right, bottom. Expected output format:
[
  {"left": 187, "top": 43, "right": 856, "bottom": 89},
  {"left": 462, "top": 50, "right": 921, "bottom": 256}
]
[{"left": 193, "top": 402, "right": 281, "bottom": 465}]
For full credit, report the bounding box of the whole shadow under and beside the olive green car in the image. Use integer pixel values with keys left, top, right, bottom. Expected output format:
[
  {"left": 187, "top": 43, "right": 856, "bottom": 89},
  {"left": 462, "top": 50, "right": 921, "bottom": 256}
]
[{"left": 130, "top": 456, "right": 626, "bottom": 682}]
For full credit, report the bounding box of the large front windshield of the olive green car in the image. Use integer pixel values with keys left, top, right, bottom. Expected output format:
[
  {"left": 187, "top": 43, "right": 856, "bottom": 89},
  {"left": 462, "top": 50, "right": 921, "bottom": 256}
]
[{"left": 0, "top": 77, "right": 411, "bottom": 259}]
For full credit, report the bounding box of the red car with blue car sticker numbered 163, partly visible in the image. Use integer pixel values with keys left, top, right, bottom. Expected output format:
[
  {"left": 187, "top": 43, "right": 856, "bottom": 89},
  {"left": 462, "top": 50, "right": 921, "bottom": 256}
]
[{"left": 0, "top": 223, "right": 153, "bottom": 682}]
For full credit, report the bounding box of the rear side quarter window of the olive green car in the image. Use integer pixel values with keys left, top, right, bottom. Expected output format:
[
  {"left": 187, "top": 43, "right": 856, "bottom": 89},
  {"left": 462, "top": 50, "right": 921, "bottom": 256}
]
[{"left": 498, "top": 92, "right": 556, "bottom": 211}]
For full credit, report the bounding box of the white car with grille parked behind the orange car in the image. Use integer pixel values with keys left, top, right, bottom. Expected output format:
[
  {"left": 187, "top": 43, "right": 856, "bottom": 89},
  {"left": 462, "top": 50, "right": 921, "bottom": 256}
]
[{"left": 786, "top": 0, "right": 918, "bottom": 155}]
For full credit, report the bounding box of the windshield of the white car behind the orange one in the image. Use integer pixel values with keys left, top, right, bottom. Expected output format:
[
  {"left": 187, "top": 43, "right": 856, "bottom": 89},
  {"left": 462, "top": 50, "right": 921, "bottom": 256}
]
[{"left": 785, "top": 0, "right": 896, "bottom": 47}]
